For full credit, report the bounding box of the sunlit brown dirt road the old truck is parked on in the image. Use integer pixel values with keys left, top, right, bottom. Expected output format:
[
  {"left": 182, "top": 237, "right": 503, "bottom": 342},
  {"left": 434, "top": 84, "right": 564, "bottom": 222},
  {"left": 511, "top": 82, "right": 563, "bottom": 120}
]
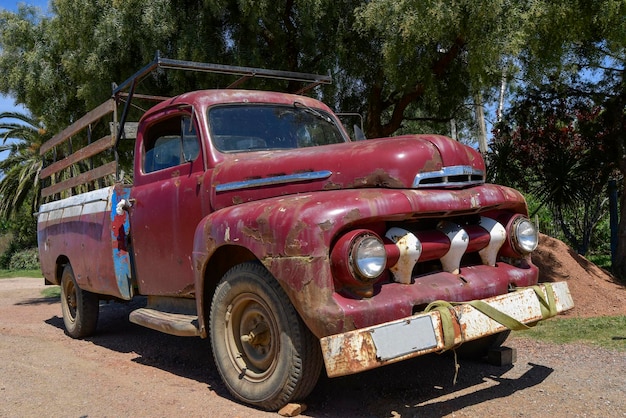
[{"left": 0, "top": 279, "right": 626, "bottom": 418}]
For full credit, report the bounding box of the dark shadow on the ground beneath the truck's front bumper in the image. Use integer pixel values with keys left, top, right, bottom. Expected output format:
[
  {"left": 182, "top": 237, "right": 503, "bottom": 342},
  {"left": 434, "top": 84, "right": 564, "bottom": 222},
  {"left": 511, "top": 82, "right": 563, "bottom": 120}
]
[{"left": 307, "top": 354, "right": 553, "bottom": 417}]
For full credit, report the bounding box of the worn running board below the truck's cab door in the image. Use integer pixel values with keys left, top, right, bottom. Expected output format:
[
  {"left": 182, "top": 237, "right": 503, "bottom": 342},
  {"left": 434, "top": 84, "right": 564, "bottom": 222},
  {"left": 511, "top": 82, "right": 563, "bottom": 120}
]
[{"left": 128, "top": 308, "right": 200, "bottom": 337}]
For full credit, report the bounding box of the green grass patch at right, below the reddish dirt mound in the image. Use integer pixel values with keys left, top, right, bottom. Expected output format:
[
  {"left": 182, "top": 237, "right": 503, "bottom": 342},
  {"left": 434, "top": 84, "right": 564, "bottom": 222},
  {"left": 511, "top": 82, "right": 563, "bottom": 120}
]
[{"left": 517, "top": 315, "right": 626, "bottom": 352}]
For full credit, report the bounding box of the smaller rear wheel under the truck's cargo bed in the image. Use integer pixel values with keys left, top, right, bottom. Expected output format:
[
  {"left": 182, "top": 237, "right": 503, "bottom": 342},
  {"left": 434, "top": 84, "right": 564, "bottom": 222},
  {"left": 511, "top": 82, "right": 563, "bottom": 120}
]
[{"left": 61, "top": 264, "right": 100, "bottom": 338}]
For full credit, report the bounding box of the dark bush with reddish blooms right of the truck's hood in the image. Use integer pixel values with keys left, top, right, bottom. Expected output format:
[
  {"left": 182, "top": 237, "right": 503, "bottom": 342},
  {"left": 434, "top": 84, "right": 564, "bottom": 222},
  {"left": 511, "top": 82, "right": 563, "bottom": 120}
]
[{"left": 487, "top": 91, "right": 616, "bottom": 254}]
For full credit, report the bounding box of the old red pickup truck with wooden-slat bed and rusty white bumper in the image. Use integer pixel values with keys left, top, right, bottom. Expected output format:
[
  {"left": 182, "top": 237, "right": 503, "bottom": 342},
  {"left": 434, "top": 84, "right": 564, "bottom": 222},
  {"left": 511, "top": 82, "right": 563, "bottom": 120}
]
[{"left": 38, "top": 57, "right": 573, "bottom": 410}]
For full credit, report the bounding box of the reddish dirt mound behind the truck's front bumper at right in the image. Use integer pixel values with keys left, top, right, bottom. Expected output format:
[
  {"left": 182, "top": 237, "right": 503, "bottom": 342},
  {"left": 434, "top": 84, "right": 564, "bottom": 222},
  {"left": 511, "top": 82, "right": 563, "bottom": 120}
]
[{"left": 532, "top": 234, "right": 626, "bottom": 317}]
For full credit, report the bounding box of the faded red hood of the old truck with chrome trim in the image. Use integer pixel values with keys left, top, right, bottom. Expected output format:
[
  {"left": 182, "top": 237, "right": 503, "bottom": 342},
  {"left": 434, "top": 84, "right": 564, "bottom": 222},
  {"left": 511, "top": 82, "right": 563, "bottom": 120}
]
[{"left": 212, "top": 135, "right": 485, "bottom": 209}]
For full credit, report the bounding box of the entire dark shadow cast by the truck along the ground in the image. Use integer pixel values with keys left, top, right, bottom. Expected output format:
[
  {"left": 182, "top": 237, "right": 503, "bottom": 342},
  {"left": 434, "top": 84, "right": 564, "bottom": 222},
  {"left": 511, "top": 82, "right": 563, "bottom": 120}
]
[{"left": 46, "top": 301, "right": 553, "bottom": 417}]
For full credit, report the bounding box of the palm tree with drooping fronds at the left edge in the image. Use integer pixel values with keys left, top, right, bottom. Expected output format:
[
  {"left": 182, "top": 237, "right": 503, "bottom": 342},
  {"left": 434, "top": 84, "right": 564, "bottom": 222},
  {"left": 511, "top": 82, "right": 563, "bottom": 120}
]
[{"left": 0, "top": 112, "right": 50, "bottom": 219}]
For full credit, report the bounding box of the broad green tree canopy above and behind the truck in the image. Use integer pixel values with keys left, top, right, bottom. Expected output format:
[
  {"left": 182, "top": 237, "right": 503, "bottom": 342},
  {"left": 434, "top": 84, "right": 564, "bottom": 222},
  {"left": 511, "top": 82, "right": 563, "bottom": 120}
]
[{"left": 0, "top": 0, "right": 540, "bottom": 137}]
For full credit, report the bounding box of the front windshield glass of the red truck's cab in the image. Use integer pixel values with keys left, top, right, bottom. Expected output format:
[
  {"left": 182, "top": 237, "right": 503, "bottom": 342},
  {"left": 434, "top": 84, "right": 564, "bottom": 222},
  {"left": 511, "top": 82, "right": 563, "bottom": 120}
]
[{"left": 209, "top": 105, "right": 346, "bottom": 152}]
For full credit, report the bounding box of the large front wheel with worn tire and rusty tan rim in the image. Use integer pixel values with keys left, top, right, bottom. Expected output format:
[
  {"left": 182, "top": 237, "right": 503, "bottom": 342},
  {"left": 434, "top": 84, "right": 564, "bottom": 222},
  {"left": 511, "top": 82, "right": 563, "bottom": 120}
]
[{"left": 209, "top": 263, "right": 322, "bottom": 411}]
